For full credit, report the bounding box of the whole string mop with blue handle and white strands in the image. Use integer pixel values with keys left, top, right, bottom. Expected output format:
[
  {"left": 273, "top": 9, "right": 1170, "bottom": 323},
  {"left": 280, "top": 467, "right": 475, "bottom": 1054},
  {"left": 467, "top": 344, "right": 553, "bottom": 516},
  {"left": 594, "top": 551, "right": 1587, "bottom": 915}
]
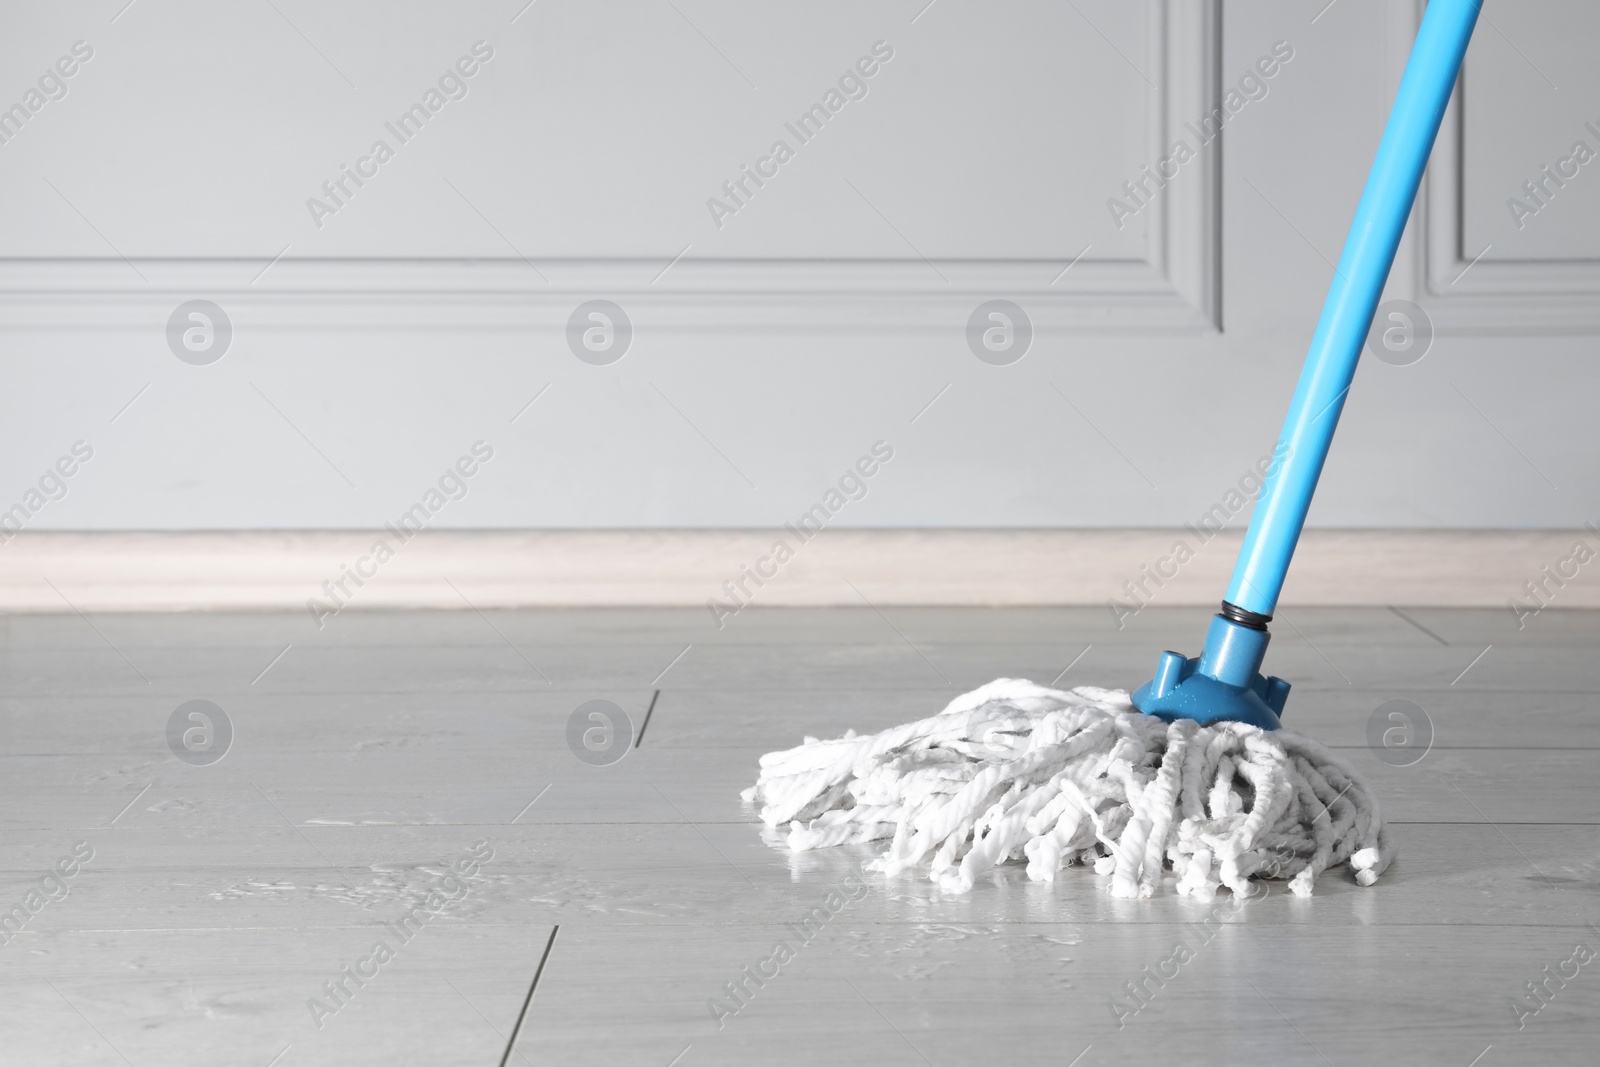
[{"left": 742, "top": 0, "right": 1480, "bottom": 899}]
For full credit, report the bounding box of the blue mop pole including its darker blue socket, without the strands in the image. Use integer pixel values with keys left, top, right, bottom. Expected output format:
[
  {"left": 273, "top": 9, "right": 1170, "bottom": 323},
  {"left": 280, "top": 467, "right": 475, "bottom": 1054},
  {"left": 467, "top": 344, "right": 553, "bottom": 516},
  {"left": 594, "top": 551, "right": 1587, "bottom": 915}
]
[{"left": 1134, "top": 0, "right": 1482, "bottom": 728}]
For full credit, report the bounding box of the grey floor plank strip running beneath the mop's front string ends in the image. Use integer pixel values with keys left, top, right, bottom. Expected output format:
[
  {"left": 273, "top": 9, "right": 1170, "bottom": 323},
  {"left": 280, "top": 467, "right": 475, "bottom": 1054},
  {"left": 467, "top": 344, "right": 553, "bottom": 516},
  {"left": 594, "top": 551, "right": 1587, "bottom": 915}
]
[{"left": 0, "top": 822, "right": 1600, "bottom": 927}]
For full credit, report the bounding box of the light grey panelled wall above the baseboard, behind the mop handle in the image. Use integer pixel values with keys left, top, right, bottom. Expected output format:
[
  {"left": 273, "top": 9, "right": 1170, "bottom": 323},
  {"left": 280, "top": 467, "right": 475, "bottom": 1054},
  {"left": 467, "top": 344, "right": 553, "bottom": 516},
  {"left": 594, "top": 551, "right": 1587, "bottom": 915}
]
[{"left": 0, "top": 0, "right": 1600, "bottom": 530}]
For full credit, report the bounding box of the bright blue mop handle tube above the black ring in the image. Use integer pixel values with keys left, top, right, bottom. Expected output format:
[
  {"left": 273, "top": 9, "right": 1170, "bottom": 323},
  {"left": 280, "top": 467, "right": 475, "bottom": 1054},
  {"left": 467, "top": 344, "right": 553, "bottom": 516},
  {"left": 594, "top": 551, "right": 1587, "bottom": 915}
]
[{"left": 1227, "top": 0, "right": 1482, "bottom": 616}]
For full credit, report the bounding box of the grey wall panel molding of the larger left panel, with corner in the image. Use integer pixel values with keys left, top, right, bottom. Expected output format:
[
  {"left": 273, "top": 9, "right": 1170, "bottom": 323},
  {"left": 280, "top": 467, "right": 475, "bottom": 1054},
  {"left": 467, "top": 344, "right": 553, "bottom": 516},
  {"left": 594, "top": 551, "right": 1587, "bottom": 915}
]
[{"left": 0, "top": 0, "right": 1222, "bottom": 333}]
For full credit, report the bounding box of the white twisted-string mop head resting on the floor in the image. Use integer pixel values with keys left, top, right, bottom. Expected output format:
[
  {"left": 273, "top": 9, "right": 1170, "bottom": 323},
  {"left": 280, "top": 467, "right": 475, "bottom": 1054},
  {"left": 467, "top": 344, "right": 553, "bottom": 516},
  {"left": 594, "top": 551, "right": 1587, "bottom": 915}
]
[{"left": 744, "top": 678, "right": 1394, "bottom": 899}]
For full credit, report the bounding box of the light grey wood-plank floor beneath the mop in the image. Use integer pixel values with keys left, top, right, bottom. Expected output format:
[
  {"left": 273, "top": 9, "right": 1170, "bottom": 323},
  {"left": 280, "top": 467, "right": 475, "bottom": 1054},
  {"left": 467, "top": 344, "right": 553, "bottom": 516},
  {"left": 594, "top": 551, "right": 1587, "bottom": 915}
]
[{"left": 0, "top": 608, "right": 1600, "bottom": 1067}]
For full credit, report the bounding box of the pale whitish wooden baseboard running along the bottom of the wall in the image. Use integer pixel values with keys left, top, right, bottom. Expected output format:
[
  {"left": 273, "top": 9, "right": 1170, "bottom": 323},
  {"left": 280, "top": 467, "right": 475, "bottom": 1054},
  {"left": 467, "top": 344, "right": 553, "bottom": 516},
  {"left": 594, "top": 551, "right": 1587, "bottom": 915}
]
[{"left": 0, "top": 530, "right": 1580, "bottom": 611}]
